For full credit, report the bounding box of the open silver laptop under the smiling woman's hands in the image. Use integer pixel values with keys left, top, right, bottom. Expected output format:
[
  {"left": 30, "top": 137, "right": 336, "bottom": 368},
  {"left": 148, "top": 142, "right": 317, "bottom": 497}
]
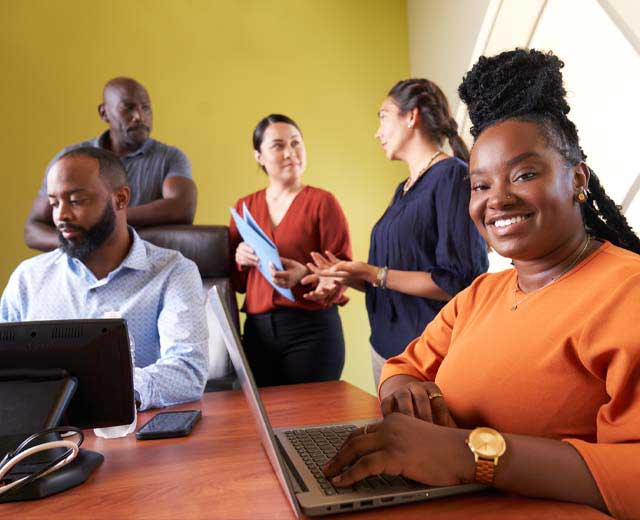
[{"left": 207, "top": 287, "right": 484, "bottom": 517}]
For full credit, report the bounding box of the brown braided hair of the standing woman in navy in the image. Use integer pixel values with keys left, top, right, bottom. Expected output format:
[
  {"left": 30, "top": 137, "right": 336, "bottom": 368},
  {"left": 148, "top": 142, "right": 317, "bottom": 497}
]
[{"left": 388, "top": 79, "right": 469, "bottom": 162}]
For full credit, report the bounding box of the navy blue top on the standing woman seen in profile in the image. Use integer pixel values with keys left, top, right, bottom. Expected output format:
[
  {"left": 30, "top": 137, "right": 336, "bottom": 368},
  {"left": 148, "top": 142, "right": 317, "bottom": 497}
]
[{"left": 365, "top": 157, "right": 489, "bottom": 358}]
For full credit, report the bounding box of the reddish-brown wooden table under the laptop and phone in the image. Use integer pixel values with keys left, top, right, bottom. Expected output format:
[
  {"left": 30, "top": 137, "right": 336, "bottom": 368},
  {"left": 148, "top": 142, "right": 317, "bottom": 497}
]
[{"left": 0, "top": 382, "right": 609, "bottom": 520}]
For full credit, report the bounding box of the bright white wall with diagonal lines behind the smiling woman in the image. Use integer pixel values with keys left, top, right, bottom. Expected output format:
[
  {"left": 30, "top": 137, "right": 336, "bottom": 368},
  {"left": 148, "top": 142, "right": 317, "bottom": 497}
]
[{"left": 407, "top": 0, "right": 640, "bottom": 264}]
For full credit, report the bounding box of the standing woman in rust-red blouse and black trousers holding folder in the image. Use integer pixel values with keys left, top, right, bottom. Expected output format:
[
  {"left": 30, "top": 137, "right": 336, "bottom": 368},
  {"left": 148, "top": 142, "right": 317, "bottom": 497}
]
[{"left": 230, "top": 114, "right": 351, "bottom": 386}]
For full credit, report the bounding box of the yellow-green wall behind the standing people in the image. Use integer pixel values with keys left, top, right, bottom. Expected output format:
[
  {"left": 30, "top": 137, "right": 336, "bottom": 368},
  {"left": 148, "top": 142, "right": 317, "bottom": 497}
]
[{"left": 0, "top": 0, "right": 409, "bottom": 390}]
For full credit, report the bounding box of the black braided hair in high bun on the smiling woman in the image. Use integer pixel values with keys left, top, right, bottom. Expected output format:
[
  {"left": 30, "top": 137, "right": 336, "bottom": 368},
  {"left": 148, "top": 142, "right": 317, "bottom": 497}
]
[{"left": 458, "top": 49, "right": 640, "bottom": 253}]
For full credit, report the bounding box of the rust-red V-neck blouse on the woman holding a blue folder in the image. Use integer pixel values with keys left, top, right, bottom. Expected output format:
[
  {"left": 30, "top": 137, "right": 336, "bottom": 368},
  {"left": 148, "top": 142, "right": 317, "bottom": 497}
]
[{"left": 229, "top": 186, "right": 351, "bottom": 314}]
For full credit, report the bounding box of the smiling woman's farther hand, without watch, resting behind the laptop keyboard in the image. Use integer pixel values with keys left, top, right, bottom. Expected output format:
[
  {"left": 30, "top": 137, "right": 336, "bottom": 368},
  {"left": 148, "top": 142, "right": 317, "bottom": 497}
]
[{"left": 380, "top": 376, "right": 458, "bottom": 428}]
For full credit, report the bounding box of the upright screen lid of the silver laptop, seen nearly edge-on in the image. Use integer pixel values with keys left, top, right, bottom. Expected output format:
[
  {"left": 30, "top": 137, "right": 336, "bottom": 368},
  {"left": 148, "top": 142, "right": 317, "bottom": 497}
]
[{"left": 206, "top": 286, "right": 301, "bottom": 518}]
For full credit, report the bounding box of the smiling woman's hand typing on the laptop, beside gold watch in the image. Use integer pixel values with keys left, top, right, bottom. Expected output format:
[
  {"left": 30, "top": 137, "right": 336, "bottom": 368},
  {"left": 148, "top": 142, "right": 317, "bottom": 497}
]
[{"left": 324, "top": 413, "right": 475, "bottom": 487}]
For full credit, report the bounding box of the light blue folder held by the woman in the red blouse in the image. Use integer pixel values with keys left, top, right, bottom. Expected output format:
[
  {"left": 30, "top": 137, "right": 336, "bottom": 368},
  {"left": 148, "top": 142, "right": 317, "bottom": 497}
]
[{"left": 230, "top": 204, "right": 295, "bottom": 302}]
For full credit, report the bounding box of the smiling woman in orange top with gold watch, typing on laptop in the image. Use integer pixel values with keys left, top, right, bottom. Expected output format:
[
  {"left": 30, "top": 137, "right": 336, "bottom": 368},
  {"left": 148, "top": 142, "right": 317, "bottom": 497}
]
[{"left": 326, "top": 49, "right": 640, "bottom": 519}]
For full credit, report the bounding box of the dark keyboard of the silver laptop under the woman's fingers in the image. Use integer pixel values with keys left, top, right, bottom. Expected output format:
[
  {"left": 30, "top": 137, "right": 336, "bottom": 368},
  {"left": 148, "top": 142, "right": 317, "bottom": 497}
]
[{"left": 284, "top": 424, "right": 413, "bottom": 495}]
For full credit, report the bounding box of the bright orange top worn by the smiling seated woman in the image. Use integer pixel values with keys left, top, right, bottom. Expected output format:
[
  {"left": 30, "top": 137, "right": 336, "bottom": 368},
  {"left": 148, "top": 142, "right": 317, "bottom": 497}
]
[{"left": 382, "top": 242, "right": 640, "bottom": 519}]
